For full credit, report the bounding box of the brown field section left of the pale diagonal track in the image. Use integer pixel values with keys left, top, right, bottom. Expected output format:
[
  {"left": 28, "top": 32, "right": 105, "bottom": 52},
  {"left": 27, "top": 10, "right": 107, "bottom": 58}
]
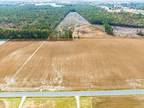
[{"left": 0, "top": 41, "right": 41, "bottom": 83}]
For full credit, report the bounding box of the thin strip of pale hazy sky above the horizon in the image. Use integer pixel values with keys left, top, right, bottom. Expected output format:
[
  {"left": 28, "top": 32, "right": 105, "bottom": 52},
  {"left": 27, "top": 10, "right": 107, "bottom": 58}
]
[{"left": 0, "top": 0, "right": 144, "bottom": 2}]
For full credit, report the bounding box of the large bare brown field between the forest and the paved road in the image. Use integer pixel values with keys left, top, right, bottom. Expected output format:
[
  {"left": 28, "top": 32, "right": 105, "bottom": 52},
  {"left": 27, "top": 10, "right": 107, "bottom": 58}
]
[{"left": 0, "top": 38, "right": 144, "bottom": 91}]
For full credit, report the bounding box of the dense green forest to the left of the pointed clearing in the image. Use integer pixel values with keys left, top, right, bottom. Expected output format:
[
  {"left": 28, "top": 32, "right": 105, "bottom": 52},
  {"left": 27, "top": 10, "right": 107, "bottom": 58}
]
[{"left": 0, "top": 5, "right": 68, "bottom": 39}]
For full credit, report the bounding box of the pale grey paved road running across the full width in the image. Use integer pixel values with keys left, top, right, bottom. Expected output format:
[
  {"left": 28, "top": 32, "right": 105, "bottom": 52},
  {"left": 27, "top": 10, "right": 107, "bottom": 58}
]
[{"left": 0, "top": 90, "right": 144, "bottom": 97}]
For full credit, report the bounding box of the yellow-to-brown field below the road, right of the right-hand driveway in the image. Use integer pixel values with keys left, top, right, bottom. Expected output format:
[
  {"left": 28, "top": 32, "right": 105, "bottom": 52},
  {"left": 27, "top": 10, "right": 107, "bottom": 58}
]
[{"left": 81, "top": 96, "right": 144, "bottom": 108}]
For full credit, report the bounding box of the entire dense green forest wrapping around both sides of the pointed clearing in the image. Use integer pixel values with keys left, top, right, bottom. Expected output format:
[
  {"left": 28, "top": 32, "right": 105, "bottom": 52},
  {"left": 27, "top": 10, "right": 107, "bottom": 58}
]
[{"left": 0, "top": 4, "right": 144, "bottom": 39}]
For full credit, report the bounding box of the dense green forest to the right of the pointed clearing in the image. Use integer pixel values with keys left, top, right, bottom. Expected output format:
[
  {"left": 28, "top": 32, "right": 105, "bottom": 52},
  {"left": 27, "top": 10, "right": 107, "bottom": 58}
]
[{"left": 75, "top": 6, "right": 144, "bottom": 27}]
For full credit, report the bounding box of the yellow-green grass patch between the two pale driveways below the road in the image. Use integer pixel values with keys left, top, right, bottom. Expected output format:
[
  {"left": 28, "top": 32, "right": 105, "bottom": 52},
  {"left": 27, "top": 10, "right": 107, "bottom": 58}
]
[{"left": 22, "top": 97, "right": 76, "bottom": 108}]
